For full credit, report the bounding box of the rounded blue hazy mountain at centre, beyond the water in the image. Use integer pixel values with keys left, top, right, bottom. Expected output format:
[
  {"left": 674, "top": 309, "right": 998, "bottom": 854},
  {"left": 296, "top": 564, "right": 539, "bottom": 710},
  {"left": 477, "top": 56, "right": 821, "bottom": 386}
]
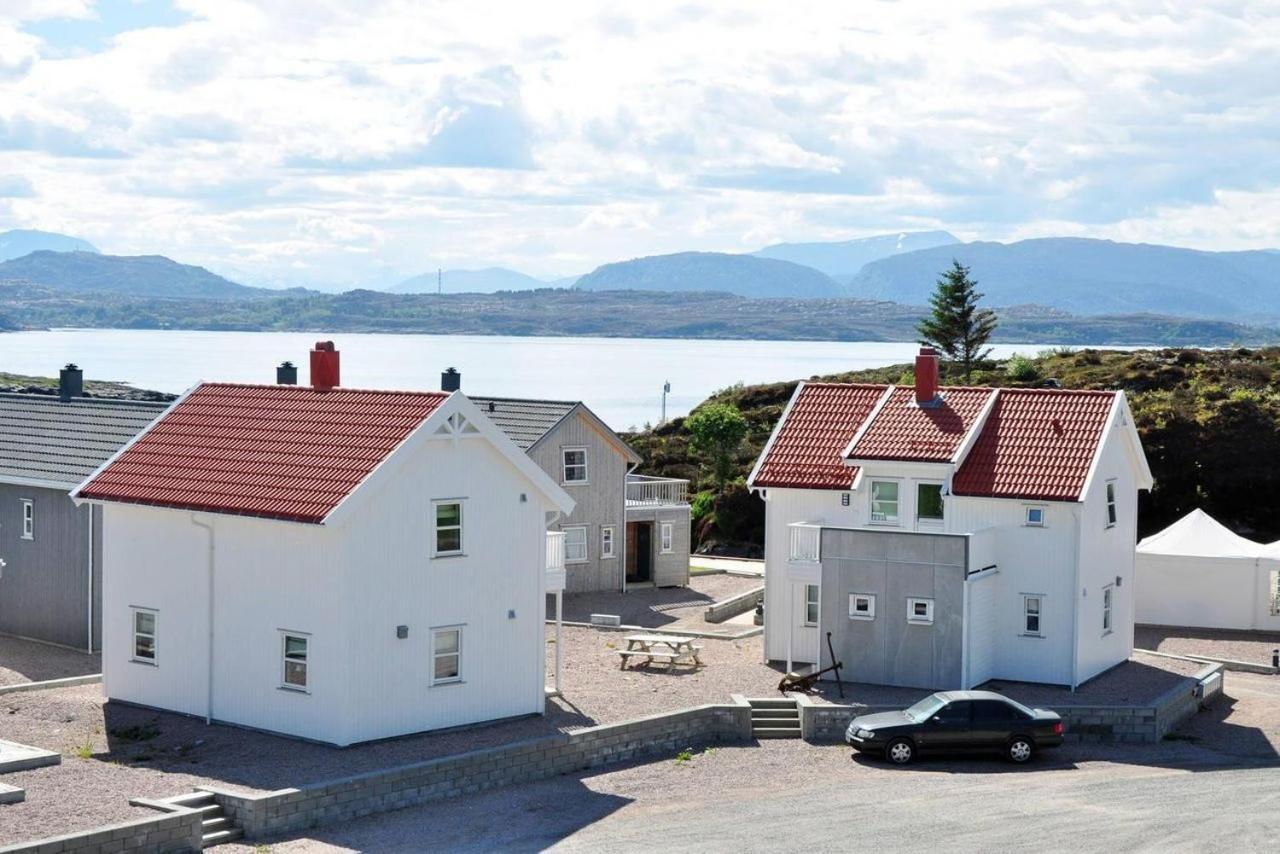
[{"left": 573, "top": 252, "right": 842, "bottom": 297}]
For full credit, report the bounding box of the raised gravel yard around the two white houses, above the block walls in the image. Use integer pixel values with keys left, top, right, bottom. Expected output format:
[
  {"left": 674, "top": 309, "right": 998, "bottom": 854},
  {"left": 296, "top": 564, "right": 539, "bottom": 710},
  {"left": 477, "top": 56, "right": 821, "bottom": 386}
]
[{"left": 0, "top": 626, "right": 1239, "bottom": 844}]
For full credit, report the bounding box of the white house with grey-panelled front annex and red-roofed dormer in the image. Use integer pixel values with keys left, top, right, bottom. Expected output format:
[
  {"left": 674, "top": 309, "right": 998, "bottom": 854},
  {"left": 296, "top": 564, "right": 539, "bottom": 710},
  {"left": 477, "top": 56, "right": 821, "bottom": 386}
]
[{"left": 748, "top": 348, "right": 1152, "bottom": 689}]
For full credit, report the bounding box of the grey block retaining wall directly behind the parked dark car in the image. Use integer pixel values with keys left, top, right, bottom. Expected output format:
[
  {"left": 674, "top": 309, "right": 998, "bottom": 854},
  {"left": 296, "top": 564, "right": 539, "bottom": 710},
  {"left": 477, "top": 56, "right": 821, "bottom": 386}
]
[{"left": 799, "top": 665, "right": 1222, "bottom": 743}]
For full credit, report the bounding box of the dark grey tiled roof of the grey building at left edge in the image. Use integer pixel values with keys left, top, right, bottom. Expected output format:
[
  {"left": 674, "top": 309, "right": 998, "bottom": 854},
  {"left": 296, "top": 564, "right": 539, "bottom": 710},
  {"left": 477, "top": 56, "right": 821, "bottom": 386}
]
[{"left": 0, "top": 394, "right": 169, "bottom": 485}]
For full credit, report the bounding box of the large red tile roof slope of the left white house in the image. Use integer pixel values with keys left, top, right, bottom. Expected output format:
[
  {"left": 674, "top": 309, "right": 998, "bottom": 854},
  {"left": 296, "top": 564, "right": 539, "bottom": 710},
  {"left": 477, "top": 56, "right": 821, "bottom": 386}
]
[{"left": 78, "top": 383, "right": 448, "bottom": 522}]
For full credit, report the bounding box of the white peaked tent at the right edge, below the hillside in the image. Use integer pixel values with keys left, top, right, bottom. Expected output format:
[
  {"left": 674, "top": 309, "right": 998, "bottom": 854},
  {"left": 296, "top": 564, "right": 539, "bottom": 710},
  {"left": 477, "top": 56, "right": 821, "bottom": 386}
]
[{"left": 1135, "top": 508, "right": 1280, "bottom": 631}]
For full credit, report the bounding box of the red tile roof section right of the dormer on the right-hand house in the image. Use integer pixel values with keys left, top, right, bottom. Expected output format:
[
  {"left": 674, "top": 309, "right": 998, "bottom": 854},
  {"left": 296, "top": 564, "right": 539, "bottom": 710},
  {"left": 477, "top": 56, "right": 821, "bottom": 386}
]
[{"left": 951, "top": 388, "right": 1116, "bottom": 501}]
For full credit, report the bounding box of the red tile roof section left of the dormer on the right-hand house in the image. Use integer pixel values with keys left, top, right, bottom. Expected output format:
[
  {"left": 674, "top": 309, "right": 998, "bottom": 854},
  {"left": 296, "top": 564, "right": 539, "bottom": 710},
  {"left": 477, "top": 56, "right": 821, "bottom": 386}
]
[{"left": 753, "top": 383, "right": 886, "bottom": 489}]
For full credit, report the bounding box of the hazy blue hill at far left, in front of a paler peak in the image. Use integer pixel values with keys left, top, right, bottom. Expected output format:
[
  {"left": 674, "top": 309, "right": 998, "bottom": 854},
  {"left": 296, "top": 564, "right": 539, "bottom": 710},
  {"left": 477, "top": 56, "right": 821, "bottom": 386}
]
[{"left": 0, "top": 251, "right": 263, "bottom": 300}]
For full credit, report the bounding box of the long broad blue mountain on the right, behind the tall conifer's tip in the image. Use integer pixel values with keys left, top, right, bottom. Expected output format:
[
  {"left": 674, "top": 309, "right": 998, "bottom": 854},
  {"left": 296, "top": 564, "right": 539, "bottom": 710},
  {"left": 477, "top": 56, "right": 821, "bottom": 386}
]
[{"left": 849, "top": 237, "right": 1280, "bottom": 320}]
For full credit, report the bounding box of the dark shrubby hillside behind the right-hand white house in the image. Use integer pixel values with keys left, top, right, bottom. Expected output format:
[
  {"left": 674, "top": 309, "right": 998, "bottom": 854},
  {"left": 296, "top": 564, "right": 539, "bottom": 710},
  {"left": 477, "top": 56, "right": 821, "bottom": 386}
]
[{"left": 627, "top": 347, "right": 1280, "bottom": 554}]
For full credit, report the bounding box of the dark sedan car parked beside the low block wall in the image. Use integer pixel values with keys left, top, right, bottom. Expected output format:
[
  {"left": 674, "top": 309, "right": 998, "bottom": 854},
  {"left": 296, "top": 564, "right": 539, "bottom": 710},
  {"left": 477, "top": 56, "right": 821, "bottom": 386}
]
[{"left": 845, "top": 691, "right": 1062, "bottom": 764}]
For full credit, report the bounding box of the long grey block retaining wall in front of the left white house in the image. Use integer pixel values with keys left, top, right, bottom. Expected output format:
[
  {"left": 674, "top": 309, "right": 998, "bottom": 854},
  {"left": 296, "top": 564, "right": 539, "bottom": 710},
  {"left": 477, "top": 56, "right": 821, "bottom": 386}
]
[{"left": 201, "top": 703, "right": 751, "bottom": 839}]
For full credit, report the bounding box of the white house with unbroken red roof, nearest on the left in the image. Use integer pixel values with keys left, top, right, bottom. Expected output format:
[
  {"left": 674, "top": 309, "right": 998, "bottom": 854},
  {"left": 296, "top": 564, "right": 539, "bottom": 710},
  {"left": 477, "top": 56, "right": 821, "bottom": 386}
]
[{"left": 74, "top": 342, "right": 573, "bottom": 745}]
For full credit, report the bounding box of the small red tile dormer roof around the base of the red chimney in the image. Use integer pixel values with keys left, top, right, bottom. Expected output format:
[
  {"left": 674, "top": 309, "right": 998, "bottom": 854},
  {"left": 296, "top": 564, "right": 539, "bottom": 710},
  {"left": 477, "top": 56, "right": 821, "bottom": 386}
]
[{"left": 849, "top": 388, "right": 995, "bottom": 462}]
